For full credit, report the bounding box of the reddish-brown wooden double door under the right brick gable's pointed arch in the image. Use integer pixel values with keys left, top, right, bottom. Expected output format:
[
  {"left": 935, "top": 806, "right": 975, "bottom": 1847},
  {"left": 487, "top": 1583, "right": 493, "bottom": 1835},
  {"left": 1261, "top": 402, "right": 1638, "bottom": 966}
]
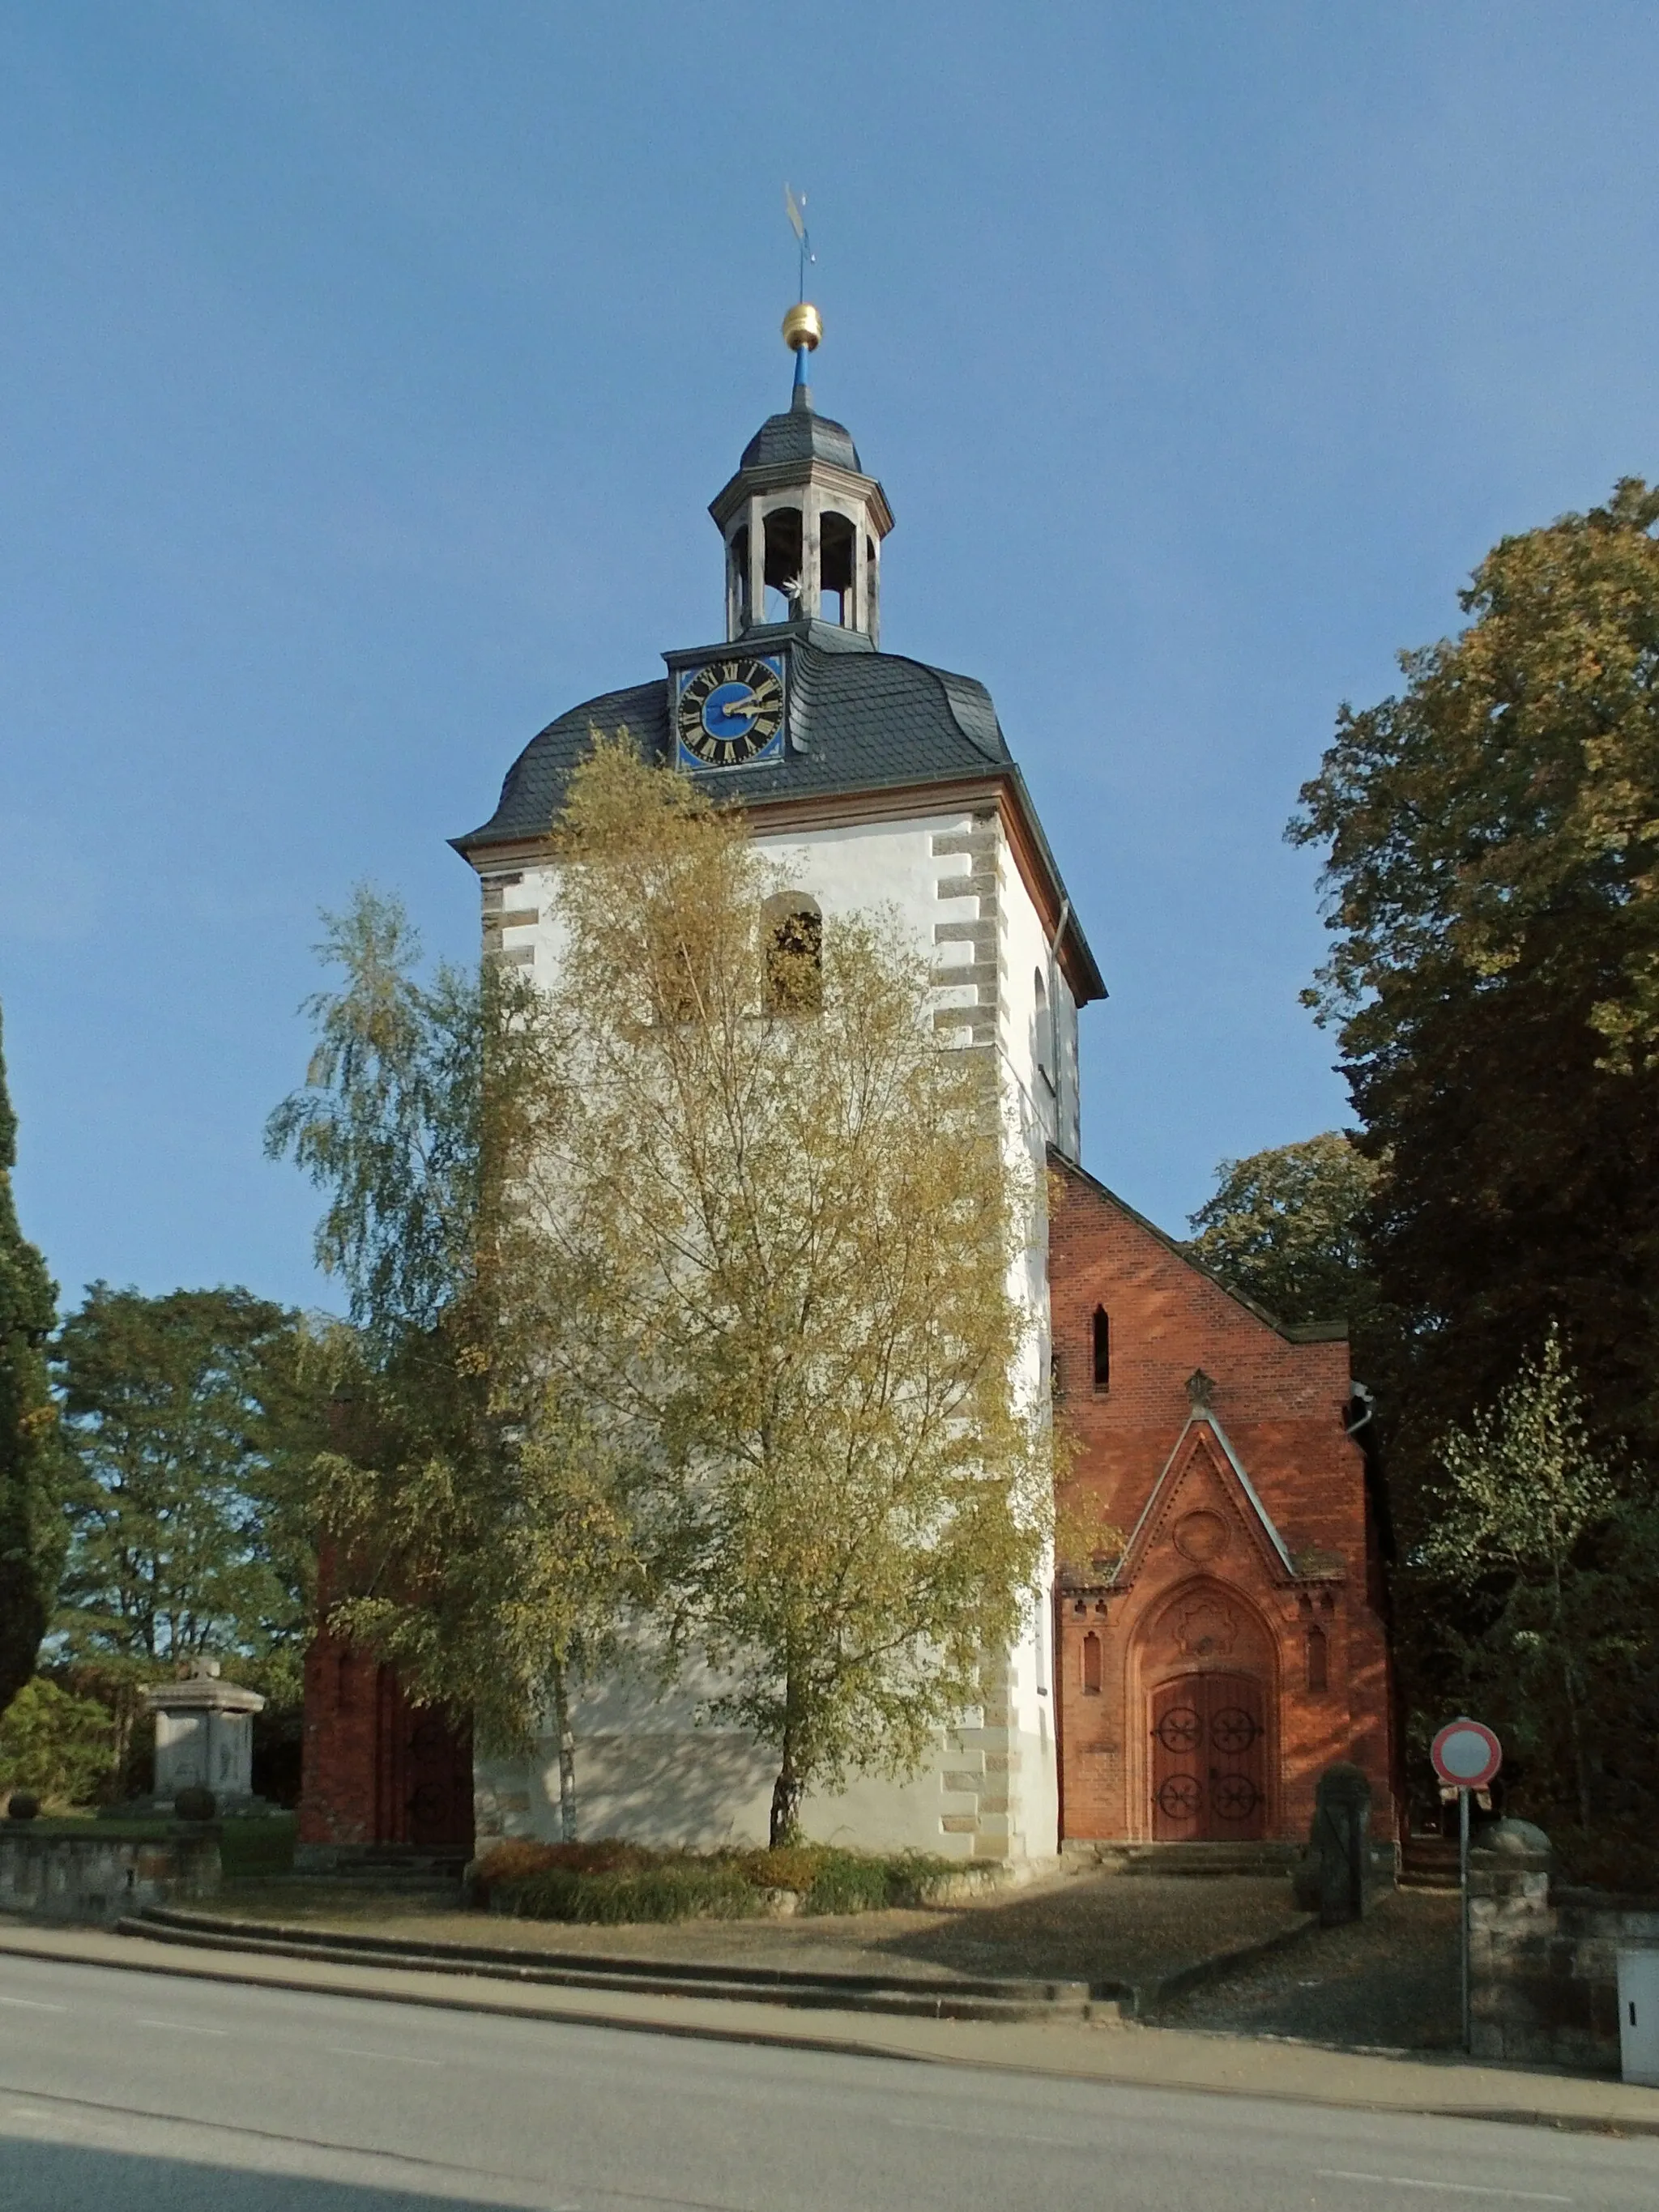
[{"left": 1153, "top": 1673, "right": 1268, "bottom": 1843}]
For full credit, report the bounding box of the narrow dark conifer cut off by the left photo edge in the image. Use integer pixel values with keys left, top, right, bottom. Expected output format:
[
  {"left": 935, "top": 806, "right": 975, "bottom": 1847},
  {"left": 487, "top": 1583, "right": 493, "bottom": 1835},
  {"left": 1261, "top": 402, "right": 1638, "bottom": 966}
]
[{"left": 0, "top": 1004, "right": 66, "bottom": 1715}]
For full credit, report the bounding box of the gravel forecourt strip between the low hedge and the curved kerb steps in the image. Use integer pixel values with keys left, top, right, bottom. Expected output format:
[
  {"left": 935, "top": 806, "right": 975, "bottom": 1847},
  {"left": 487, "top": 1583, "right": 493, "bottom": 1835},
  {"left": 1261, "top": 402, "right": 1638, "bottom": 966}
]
[{"left": 210, "top": 1873, "right": 1303, "bottom": 1984}]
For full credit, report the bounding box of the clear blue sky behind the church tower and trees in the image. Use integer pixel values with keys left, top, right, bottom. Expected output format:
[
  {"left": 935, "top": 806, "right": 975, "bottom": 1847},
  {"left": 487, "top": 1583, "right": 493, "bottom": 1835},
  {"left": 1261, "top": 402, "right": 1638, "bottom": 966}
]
[{"left": 0, "top": 0, "right": 1659, "bottom": 1303}]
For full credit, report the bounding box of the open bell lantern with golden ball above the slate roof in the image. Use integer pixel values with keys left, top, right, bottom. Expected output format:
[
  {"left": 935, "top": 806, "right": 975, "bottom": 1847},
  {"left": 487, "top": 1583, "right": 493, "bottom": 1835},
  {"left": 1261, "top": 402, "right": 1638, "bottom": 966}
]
[{"left": 708, "top": 300, "right": 893, "bottom": 646}]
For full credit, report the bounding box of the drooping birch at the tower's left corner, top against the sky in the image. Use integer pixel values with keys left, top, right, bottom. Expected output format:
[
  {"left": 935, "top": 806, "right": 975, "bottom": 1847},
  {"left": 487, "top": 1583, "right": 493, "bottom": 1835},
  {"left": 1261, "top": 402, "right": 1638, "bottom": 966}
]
[{"left": 267, "top": 889, "right": 642, "bottom": 1838}]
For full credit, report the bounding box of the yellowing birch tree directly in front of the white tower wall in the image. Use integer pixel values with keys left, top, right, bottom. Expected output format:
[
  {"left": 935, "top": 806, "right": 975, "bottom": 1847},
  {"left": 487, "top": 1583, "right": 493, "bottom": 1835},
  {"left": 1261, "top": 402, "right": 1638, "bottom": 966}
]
[{"left": 539, "top": 741, "right": 1053, "bottom": 1843}]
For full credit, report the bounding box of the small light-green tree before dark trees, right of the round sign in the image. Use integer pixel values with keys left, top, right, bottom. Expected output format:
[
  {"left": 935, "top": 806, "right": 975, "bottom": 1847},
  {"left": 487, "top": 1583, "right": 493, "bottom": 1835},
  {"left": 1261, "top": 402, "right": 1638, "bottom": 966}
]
[{"left": 1414, "top": 1329, "right": 1659, "bottom": 1834}]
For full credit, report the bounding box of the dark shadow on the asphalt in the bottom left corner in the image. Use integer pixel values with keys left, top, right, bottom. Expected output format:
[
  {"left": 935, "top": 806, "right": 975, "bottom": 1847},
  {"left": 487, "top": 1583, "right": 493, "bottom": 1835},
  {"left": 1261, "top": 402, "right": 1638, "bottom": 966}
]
[{"left": 0, "top": 2132, "right": 524, "bottom": 2212}]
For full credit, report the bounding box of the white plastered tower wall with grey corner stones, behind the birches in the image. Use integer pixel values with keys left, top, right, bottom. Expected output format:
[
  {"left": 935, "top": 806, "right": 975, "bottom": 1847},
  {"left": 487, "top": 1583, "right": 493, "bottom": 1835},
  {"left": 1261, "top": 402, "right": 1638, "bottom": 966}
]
[{"left": 478, "top": 805, "right": 1077, "bottom": 1860}]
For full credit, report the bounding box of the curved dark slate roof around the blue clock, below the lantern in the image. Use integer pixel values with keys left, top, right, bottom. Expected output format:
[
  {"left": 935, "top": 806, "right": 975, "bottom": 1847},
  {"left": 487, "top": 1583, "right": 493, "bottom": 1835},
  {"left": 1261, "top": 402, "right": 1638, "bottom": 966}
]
[{"left": 454, "top": 621, "right": 1013, "bottom": 851}]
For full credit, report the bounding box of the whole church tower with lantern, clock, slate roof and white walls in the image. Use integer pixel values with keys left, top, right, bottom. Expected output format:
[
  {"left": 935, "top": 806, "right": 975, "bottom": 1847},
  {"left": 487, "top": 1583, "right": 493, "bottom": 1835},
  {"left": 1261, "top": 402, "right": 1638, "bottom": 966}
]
[{"left": 456, "top": 303, "right": 1104, "bottom": 1858}]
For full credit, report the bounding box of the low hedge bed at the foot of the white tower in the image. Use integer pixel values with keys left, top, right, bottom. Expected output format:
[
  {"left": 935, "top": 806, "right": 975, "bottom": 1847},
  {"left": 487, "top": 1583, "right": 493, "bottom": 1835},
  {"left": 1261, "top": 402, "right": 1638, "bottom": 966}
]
[{"left": 473, "top": 1836, "right": 962, "bottom": 1924}]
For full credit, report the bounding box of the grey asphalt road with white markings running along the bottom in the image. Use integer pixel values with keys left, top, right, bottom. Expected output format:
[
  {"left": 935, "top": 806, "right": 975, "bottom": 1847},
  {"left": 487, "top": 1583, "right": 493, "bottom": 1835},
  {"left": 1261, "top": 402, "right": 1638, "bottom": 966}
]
[{"left": 0, "top": 1955, "right": 1659, "bottom": 2212}]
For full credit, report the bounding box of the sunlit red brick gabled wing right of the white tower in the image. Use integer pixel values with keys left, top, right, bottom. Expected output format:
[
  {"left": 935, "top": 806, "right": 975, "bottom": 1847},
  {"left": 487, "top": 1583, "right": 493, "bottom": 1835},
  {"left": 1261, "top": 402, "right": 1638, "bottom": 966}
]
[{"left": 1048, "top": 1161, "right": 1392, "bottom": 1840}]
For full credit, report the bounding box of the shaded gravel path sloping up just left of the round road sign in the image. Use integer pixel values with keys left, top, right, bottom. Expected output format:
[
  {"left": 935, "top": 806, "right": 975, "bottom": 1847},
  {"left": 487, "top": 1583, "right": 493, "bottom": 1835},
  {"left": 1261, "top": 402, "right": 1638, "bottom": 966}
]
[{"left": 1159, "top": 1889, "right": 1462, "bottom": 2051}]
